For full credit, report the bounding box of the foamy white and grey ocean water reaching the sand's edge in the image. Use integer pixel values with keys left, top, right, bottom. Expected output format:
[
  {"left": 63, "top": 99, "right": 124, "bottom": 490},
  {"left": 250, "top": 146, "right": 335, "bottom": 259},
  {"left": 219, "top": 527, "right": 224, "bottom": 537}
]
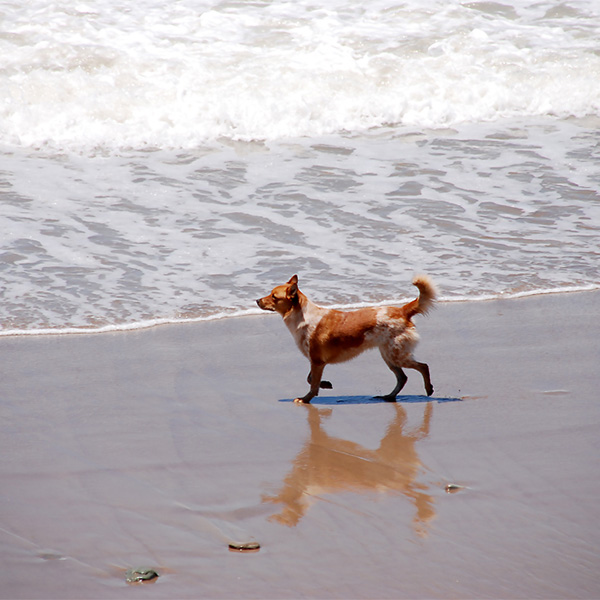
[{"left": 0, "top": 0, "right": 600, "bottom": 335}]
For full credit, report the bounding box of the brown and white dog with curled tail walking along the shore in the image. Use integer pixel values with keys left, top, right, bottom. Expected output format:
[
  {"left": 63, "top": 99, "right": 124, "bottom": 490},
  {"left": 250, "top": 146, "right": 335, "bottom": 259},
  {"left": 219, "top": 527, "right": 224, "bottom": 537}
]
[{"left": 256, "top": 275, "right": 436, "bottom": 403}]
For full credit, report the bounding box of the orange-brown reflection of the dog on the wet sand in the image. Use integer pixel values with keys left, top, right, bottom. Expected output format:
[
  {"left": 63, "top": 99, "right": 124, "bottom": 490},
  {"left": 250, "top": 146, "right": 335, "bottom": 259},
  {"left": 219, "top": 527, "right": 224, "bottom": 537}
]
[{"left": 263, "top": 402, "right": 435, "bottom": 536}]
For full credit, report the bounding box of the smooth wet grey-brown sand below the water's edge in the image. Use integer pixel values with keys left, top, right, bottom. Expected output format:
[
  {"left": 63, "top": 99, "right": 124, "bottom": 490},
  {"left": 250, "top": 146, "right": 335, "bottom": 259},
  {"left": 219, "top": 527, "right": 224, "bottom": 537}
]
[{"left": 0, "top": 292, "right": 600, "bottom": 599}]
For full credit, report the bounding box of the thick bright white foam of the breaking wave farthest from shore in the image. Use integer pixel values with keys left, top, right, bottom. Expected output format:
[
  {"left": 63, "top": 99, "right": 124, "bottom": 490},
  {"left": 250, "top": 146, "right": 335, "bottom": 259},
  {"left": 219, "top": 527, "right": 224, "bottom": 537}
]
[{"left": 0, "top": 0, "right": 600, "bottom": 151}]
